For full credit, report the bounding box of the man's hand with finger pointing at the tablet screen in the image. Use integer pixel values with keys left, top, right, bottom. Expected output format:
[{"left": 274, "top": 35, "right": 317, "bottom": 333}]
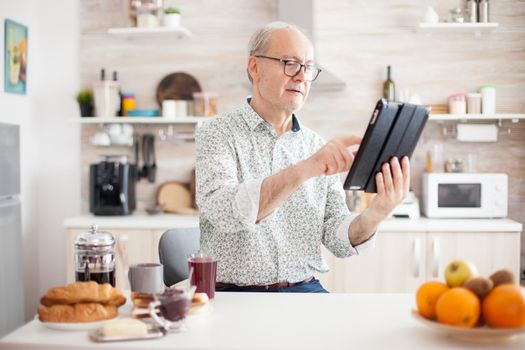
[{"left": 304, "top": 136, "right": 362, "bottom": 177}]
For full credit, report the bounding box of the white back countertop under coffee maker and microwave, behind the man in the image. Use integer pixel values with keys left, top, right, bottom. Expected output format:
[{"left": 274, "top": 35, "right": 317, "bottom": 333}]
[{"left": 64, "top": 213, "right": 523, "bottom": 232}]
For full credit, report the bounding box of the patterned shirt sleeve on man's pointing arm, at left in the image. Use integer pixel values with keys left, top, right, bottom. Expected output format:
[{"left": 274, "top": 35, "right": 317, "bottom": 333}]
[{"left": 195, "top": 126, "right": 263, "bottom": 232}]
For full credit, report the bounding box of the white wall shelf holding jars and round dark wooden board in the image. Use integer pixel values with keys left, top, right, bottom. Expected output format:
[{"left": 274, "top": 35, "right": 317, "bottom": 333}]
[{"left": 71, "top": 116, "right": 214, "bottom": 125}]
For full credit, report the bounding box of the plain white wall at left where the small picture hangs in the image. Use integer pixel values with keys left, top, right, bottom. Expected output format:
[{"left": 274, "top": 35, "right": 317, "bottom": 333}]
[{"left": 0, "top": 0, "right": 80, "bottom": 318}]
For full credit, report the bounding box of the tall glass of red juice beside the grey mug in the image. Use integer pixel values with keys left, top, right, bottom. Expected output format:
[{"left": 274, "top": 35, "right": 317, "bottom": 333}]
[{"left": 188, "top": 255, "right": 217, "bottom": 299}]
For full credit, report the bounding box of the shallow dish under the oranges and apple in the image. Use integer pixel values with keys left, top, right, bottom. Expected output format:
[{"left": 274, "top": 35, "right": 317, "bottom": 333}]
[{"left": 412, "top": 309, "right": 525, "bottom": 343}]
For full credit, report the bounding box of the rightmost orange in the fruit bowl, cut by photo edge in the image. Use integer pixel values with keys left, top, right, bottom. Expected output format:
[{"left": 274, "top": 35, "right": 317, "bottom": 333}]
[{"left": 483, "top": 284, "right": 525, "bottom": 328}]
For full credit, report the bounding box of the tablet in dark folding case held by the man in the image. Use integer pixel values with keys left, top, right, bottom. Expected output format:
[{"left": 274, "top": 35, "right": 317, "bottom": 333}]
[{"left": 343, "top": 99, "right": 429, "bottom": 193}]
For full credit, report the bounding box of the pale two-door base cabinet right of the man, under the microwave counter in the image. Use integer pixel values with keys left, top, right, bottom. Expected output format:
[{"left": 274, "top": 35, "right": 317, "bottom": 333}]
[{"left": 324, "top": 231, "right": 521, "bottom": 293}]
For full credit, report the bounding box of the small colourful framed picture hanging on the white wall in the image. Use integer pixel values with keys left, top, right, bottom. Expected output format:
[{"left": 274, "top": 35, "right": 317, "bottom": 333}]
[{"left": 4, "top": 19, "right": 28, "bottom": 95}]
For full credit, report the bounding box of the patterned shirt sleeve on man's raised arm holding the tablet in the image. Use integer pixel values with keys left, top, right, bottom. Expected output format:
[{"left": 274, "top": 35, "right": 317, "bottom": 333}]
[{"left": 322, "top": 174, "right": 376, "bottom": 258}]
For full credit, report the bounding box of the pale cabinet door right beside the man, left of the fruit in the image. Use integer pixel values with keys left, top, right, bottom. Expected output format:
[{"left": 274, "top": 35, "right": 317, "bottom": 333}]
[{"left": 331, "top": 232, "right": 426, "bottom": 293}]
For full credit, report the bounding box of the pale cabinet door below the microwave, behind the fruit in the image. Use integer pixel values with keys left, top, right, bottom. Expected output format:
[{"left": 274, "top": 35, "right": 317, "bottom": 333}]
[{"left": 426, "top": 232, "right": 520, "bottom": 281}]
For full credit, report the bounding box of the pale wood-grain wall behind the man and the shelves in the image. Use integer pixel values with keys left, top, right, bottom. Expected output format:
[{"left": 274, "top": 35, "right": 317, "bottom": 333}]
[{"left": 80, "top": 0, "right": 525, "bottom": 276}]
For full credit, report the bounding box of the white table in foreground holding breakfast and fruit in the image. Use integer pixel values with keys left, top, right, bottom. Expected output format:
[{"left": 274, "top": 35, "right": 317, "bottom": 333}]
[{"left": 0, "top": 293, "right": 525, "bottom": 350}]
